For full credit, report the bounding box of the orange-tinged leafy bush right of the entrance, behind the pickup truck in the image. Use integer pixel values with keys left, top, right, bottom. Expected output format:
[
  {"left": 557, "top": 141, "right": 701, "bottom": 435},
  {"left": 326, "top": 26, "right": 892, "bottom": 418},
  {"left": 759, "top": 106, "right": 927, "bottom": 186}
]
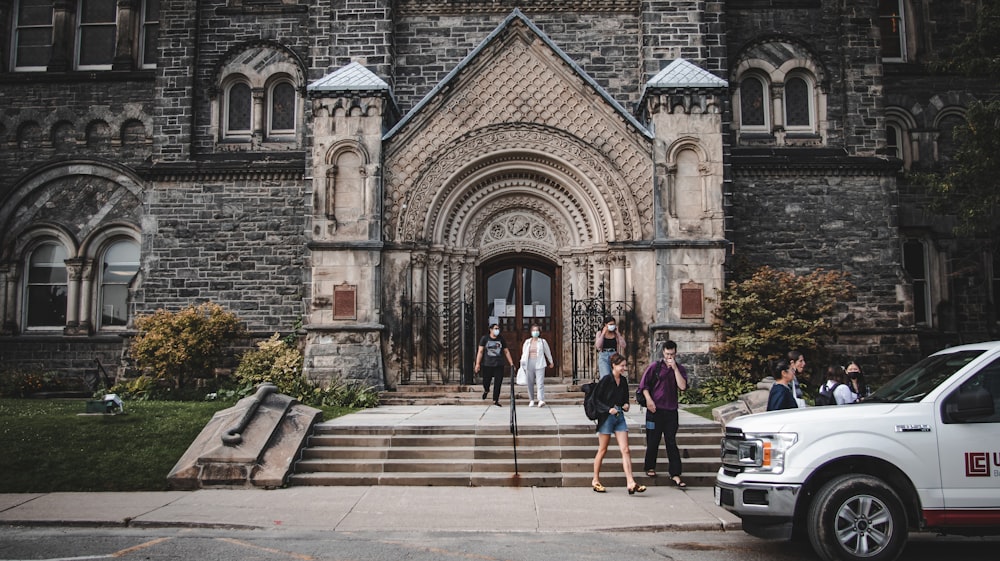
[{"left": 712, "top": 267, "right": 854, "bottom": 380}]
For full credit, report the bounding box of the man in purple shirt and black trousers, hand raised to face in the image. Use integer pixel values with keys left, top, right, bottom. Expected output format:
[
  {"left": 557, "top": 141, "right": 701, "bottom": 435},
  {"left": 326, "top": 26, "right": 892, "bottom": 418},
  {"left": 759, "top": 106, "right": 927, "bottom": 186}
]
[{"left": 639, "top": 340, "right": 687, "bottom": 489}]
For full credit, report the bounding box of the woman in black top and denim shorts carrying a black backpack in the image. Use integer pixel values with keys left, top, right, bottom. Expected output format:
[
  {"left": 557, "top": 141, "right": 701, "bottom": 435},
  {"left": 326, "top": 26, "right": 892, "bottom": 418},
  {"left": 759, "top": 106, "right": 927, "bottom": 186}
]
[{"left": 591, "top": 353, "right": 646, "bottom": 495}]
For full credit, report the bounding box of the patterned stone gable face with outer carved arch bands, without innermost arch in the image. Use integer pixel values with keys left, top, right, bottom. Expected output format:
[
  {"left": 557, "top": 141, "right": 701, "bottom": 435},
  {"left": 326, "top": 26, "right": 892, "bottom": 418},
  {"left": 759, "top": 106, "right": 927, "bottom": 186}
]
[{"left": 384, "top": 17, "right": 653, "bottom": 246}]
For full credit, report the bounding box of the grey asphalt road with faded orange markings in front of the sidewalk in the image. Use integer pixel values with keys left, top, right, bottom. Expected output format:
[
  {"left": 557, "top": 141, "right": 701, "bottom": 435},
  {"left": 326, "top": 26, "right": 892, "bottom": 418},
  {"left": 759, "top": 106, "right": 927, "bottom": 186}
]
[{"left": 0, "top": 527, "right": 1000, "bottom": 561}]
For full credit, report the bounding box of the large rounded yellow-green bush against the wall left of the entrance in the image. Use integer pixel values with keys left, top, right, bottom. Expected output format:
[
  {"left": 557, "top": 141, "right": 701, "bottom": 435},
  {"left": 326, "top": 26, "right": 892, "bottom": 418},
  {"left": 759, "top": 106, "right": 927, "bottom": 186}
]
[{"left": 129, "top": 302, "right": 243, "bottom": 390}]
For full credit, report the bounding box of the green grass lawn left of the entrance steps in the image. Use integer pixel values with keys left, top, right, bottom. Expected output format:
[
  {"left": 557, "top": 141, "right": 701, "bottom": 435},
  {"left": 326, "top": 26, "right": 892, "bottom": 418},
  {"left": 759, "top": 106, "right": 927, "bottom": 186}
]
[{"left": 0, "top": 399, "right": 351, "bottom": 493}]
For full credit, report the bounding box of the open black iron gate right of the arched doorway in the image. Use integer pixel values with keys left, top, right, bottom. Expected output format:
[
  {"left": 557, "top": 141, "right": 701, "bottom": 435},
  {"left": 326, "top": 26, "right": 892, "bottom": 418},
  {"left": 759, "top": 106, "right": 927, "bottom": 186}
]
[{"left": 569, "top": 283, "right": 645, "bottom": 384}]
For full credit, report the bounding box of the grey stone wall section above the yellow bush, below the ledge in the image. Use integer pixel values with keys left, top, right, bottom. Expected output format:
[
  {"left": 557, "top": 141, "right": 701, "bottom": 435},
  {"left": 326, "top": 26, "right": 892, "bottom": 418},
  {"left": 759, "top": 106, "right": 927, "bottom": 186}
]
[{"left": 135, "top": 176, "right": 305, "bottom": 332}]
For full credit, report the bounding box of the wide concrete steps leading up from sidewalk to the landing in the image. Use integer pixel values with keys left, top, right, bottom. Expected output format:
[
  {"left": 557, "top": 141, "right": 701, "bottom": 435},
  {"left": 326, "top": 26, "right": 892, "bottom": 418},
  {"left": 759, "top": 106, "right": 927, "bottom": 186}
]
[{"left": 290, "top": 416, "right": 721, "bottom": 487}]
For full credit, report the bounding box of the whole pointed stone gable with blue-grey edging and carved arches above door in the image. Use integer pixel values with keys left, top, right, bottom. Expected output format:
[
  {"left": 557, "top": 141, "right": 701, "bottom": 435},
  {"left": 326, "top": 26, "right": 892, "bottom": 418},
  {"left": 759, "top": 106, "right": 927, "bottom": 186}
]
[{"left": 384, "top": 10, "right": 653, "bottom": 246}]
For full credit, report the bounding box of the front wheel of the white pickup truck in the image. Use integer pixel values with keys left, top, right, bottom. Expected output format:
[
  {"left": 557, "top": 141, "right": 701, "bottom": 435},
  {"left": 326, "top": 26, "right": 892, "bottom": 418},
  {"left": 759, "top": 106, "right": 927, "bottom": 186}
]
[{"left": 806, "top": 475, "right": 907, "bottom": 561}]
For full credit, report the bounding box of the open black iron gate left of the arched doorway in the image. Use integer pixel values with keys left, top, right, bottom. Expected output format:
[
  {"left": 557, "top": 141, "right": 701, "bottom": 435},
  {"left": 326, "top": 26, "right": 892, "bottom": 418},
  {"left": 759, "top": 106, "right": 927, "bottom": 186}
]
[{"left": 400, "top": 301, "right": 476, "bottom": 384}]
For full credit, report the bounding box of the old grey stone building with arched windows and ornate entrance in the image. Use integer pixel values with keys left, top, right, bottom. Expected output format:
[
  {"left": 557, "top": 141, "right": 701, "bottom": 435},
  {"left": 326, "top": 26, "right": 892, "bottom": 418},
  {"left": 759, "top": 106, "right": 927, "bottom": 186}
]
[{"left": 0, "top": 0, "right": 1000, "bottom": 388}]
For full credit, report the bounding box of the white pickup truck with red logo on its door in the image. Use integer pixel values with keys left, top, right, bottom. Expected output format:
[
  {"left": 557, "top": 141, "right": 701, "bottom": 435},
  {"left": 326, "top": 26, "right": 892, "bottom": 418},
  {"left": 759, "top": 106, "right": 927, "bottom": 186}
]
[{"left": 715, "top": 341, "right": 1000, "bottom": 561}]
